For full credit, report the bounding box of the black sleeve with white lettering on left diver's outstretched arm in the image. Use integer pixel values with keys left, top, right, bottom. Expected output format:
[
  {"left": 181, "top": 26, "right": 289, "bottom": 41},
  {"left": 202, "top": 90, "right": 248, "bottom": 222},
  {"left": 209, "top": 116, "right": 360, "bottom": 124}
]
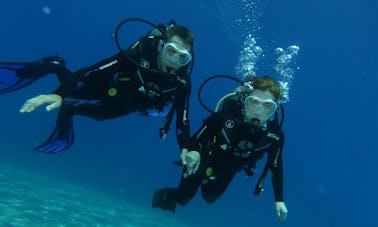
[{"left": 52, "top": 52, "right": 135, "bottom": 98}]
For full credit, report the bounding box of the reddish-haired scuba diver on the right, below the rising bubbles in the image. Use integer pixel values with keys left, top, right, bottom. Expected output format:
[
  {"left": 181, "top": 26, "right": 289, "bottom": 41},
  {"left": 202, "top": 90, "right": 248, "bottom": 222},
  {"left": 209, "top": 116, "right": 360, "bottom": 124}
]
[{"left": 152, "top": 76, "right": 287, "bottom": 222}]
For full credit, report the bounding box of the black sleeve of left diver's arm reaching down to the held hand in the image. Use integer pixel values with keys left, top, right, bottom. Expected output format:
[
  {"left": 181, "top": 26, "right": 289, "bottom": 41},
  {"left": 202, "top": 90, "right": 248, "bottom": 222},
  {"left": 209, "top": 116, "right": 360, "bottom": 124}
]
[{"left": 175, "top": 82, "right": 191, "bottom": 151}]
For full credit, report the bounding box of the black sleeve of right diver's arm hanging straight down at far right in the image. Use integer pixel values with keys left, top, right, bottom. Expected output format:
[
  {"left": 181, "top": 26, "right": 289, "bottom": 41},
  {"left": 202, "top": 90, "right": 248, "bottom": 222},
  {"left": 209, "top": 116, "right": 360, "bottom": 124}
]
[{"left": 268, "top": 132, "right": 284, "bottom": 202}]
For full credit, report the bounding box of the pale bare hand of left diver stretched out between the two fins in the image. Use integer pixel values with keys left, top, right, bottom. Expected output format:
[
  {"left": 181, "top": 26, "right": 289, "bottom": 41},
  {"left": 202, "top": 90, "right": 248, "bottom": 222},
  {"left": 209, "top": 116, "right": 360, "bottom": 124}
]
[{"left": 20, "top": 94, "right": 63, "bottom": 113}]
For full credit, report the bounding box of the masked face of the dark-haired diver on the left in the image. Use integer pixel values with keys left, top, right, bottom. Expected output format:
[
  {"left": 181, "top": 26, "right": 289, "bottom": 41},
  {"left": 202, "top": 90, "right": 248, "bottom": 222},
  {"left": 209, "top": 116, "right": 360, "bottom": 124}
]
[{"left": 159, "top": 36, "right": 192, "bottom": 71}]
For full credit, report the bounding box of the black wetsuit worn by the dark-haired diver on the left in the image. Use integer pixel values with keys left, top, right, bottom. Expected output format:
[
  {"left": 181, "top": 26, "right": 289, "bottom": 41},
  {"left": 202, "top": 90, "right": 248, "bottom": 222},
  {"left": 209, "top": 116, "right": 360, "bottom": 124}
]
[{"left": 42, "top": 36, "right": 191, "bottom": 153}]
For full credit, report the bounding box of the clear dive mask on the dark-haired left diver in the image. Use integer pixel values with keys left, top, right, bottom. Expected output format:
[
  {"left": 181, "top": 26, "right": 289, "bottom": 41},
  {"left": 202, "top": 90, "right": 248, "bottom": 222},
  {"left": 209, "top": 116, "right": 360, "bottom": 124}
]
[{"left": 162, "top": 42, "right": 192, "bottom": 67}]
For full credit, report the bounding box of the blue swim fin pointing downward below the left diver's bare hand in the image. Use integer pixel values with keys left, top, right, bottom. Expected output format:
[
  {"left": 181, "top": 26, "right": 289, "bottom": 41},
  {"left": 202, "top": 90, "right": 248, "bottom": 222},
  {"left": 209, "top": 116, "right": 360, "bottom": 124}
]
[{"left": 33, "top": 104, "right": 75, "bottom": 154}]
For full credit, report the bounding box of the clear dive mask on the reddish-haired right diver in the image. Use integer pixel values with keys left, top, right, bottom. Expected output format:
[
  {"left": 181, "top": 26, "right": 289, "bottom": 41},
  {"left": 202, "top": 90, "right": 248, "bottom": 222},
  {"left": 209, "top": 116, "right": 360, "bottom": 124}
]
[{"left": 244, "top": 95, "right": 278, "bottom": 117}]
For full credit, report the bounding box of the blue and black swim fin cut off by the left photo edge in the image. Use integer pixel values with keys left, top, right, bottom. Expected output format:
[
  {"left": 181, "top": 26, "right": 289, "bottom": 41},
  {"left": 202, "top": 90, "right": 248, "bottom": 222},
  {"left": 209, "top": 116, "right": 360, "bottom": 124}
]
[{"left": 0, "top": 56, "right": 68, "bottom": 94}]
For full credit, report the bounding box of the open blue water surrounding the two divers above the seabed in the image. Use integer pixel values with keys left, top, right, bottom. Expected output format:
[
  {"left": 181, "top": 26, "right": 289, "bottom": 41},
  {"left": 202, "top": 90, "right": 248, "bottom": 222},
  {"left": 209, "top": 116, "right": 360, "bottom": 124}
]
[{"left": 0, "top": 0, "right": 378, "bottom": 227}]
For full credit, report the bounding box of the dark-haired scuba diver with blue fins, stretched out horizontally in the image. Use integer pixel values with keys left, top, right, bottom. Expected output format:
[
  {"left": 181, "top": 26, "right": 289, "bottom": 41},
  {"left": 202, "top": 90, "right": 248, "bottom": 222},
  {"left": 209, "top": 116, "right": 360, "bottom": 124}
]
[{"left": 0, "top": 18, "right": 194, "bottom": 153}]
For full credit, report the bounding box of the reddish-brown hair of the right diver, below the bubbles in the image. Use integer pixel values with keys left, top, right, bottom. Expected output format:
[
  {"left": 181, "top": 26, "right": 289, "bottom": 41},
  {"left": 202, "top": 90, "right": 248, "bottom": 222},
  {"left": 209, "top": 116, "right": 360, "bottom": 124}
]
[{"left": 245, "top": 76, "right": 282, "bottom": 102}]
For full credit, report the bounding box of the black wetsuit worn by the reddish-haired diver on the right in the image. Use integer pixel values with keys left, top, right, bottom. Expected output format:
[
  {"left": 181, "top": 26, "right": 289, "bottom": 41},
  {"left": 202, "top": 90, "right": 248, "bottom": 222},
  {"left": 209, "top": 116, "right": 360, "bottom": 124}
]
[{"left": 152, "top": 98, "right": 284, "bottom": 211}]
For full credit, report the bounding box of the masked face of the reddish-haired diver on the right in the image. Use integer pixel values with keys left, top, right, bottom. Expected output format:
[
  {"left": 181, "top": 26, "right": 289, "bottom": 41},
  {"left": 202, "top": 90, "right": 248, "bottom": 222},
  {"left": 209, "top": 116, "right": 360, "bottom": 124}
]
[{"left": 244, "top": 90, "right": 277, "bottom": 126}]
